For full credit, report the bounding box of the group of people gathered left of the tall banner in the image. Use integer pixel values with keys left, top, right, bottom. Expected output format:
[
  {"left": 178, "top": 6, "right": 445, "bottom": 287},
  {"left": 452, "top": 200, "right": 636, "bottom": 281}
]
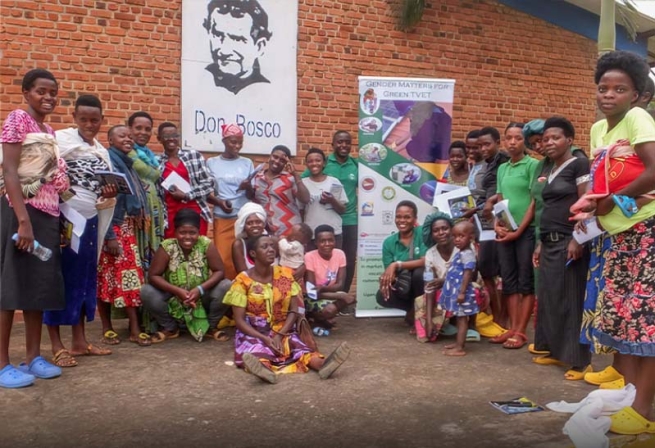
[{"left": 0, "top": 69, "right": 357, "bottom": 388}]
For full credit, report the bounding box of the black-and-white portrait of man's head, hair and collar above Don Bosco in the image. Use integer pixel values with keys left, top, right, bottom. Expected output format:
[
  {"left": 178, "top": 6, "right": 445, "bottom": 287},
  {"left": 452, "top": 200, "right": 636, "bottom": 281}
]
[{"left": 204, "top": 0, "right": 271, "bottom": 94}]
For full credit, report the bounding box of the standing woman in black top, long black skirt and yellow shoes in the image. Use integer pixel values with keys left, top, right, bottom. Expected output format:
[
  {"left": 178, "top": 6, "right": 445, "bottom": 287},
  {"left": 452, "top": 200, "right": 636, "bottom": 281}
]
[{"left": 533, "top": 117, "right": 591, "bottom": 380}]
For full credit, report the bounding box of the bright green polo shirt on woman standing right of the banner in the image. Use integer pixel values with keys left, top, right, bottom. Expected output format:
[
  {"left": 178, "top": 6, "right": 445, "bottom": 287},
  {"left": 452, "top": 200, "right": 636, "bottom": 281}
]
[{"left": 496, "top": 156, "right": 539, "bottom": 226}]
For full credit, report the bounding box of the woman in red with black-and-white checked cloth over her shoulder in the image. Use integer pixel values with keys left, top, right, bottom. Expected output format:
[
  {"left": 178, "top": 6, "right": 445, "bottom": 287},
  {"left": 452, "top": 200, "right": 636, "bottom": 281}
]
[{"left": 157, "top": 121, "right": 214, "bottom": 238}]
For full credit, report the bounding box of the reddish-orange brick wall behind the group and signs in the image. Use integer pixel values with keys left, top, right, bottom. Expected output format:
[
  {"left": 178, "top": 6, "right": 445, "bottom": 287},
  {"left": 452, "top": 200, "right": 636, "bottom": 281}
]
[{"left": 0, "top": 0, "right": 596, "bottom": 155}]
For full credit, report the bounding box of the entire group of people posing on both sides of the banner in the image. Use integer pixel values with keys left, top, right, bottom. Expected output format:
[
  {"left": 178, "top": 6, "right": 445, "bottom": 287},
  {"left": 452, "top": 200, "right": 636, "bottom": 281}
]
[{"left": 0, "top": 48, "right": 655, "bottom": 434}]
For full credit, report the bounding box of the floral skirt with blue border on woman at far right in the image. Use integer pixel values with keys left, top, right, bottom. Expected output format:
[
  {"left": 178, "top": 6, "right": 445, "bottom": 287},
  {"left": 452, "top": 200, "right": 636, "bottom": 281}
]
[{"left": 592, "top": 217, "right": 655, "bottom": 356}]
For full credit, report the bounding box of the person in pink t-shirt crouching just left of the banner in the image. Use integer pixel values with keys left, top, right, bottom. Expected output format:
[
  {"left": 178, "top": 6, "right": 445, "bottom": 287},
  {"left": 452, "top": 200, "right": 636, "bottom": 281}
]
[{"left": 305, "top": 224, "right": 355, "bottom": 336}]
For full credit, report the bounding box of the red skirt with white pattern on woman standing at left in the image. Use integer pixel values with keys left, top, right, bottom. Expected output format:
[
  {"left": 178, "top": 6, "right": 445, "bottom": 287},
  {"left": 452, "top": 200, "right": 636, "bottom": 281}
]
[{"left": 98, "top": 220, "right": 144, "bottom": 308}]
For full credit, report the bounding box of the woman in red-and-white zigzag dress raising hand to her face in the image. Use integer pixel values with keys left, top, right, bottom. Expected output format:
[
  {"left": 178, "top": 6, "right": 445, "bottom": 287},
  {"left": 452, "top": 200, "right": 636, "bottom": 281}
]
[{"left": 248, "top": 145, "right": 310, "bottom": 237}]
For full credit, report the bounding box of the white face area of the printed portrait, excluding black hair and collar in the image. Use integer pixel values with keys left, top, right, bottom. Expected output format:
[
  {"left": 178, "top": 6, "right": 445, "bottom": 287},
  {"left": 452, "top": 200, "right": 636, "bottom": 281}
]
[{"left": 209, "top": 9, "right": 266, "bottom": 78}]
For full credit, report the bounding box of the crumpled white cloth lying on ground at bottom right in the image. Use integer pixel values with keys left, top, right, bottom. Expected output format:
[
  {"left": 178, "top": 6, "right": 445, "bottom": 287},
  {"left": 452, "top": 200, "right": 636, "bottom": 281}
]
[{"left": 546, "top": 384, "right": 637, "bottom": 448}]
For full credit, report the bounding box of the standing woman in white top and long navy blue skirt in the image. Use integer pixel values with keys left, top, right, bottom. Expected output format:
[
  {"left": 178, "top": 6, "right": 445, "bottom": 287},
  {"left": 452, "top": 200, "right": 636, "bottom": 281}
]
[{"left": 43, "top": 95, "right": 117, "bottom": 367}]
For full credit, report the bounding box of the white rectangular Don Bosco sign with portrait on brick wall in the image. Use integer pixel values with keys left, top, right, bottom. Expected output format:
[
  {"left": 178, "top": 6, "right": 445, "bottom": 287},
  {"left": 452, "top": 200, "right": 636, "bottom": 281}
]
[{"left": 181, "top": 0, "right": 298, "bottom": 154}]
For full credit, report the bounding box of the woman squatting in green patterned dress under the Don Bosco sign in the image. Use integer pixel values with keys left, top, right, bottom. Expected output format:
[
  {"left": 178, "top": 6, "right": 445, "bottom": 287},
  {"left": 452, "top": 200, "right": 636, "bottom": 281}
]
[{"left": 141, "top": 209, "right": 232, "bottom": 344}]
